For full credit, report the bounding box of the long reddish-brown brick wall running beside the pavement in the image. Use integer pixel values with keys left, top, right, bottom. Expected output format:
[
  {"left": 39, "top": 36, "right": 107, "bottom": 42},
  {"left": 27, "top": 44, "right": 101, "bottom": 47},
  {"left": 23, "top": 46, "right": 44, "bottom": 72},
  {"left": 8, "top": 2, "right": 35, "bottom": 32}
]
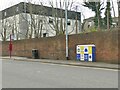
[{"left": 2, "top": 30, "right": 120, "bottom": 63}]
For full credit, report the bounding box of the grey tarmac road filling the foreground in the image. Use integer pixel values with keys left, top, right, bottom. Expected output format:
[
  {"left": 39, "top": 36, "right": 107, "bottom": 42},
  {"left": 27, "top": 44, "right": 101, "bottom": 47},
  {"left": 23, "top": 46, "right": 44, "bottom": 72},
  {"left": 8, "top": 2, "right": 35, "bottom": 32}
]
[{"left": 2, "top": 60, "right": 118, "bottom": 88}]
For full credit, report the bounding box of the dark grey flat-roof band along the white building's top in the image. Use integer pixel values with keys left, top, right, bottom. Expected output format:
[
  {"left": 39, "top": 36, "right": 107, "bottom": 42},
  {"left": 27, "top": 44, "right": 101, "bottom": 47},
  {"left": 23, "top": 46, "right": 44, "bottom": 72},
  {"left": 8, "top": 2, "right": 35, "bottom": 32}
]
[{"left": 1, "top": 2, "right": 81, "bottom": 20}]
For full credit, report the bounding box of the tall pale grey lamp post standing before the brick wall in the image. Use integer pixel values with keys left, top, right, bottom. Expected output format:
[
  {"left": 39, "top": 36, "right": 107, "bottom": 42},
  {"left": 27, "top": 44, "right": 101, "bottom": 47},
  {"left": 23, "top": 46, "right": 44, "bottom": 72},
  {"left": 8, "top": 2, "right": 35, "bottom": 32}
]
[{"left": 65, "top": 0, "right": 68, "bottom": 60}]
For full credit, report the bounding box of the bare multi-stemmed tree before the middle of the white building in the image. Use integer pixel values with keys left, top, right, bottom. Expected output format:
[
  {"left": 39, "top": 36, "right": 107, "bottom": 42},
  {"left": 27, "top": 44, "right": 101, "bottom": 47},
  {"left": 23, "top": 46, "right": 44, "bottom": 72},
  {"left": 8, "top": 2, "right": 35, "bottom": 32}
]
[{"left": 21, "top": 0, "right": 45, "bottom": 38}]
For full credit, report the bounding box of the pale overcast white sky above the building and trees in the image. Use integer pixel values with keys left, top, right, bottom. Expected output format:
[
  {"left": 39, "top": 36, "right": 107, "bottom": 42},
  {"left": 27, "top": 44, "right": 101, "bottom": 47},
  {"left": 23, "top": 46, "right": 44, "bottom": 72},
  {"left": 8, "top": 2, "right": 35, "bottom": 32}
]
[{"left": 0, "top": 0, "right": 118, "bottom": 20}]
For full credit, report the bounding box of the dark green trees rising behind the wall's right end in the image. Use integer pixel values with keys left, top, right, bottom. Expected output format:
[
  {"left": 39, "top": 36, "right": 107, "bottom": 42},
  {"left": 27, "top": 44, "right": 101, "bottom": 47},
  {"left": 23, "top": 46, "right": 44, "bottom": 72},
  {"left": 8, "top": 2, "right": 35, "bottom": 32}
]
[{"left": 83, "top": 0, "right": 117, "bottom": 30}]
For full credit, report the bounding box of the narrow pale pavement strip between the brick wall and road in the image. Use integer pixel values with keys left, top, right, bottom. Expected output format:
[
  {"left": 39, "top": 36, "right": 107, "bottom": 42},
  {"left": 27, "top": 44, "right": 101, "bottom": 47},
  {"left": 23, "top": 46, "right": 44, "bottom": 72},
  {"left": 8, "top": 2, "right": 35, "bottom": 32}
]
[{"left": 0, "top": 56, "right": 120, "bottom": 70}]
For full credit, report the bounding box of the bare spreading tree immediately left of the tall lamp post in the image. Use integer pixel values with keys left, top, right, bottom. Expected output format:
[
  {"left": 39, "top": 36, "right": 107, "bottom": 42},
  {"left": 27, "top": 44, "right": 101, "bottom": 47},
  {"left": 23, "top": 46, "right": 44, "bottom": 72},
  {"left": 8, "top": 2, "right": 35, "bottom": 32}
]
[{"left": 49, "top": 0, "right": 74, "bottom": 35}]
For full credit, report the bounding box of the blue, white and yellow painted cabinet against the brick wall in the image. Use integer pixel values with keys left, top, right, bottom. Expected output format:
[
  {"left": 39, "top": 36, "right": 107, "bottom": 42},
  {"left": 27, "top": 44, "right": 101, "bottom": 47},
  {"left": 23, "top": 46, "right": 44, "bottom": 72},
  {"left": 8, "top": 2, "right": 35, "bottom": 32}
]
[{"left": 76, "top": 44, "right": 96, "bottom": 62}]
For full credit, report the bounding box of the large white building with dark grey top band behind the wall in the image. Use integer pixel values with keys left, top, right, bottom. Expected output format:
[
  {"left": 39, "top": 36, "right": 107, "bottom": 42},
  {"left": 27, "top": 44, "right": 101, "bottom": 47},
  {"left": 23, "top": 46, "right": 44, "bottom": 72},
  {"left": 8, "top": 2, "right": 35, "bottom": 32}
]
[{"left": 0, "top": 2, "right": 81, "bottom": 40}]
